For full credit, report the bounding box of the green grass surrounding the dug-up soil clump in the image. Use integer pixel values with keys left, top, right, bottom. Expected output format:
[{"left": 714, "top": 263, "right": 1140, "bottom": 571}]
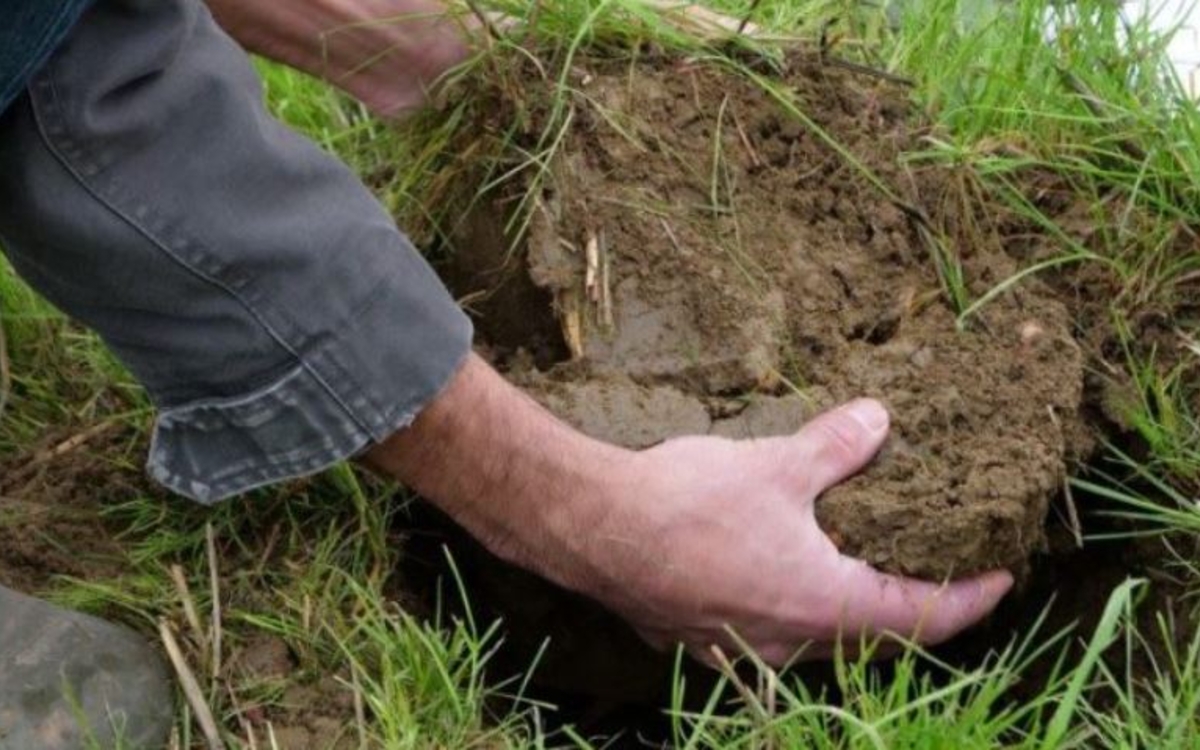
[{"left": 7, "top": 0, "right": 1200, "bottom": 749}]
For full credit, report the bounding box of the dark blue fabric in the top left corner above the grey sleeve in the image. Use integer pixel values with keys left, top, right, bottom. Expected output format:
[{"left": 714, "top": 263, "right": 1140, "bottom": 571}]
[{"left": 0, "top": 0, "right": 91, "bottom": 112}]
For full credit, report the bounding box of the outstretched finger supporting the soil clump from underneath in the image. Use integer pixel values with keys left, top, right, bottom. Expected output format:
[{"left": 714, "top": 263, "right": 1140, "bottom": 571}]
[{"left": 841, "top": 558, "right": 1013, "bottom": 646}]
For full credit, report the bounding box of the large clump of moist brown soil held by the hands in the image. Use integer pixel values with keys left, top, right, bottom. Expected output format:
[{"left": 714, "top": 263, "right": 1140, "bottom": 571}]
[{"left": 448, "top": 58, "right": 1084, "bottom": 578}]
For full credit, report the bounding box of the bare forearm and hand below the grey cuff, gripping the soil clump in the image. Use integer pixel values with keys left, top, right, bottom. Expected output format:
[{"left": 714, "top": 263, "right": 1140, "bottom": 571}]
[{"left": 368, "top": 358, "right": 1012, "bottom": 664}]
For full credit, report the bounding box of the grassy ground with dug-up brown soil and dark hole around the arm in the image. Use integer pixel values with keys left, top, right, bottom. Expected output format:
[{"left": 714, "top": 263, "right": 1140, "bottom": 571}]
[{"left": 0, "top": 0, "right": 1200, "bottom": 749}]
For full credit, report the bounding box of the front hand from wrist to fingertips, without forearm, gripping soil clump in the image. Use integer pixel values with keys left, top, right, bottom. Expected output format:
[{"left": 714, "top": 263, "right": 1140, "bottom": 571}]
[{"left": 587, "top": 400, "right": 1012, "bottom": 665}]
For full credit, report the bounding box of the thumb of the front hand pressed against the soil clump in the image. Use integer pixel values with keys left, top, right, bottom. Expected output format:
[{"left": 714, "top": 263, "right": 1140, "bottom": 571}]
[{"left": 791, "top": 398, "right": 889, "bottom": 493}]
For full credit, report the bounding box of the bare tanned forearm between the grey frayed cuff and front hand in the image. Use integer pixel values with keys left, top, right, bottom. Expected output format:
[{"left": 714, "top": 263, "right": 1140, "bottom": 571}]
[{"left": 367, "top": 355, "right": 632, "bottom": 589}]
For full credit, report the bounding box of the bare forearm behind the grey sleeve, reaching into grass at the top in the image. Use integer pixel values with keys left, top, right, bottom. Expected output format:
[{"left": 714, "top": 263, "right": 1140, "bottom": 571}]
[{"left": 208, "top": 0, "right": 473, "bottom": 114}]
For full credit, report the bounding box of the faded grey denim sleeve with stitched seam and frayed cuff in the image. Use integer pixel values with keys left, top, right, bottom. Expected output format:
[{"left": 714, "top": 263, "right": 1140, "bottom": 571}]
[{"left": 0, "top": 0, "right": 472, "bottom": 502}]
